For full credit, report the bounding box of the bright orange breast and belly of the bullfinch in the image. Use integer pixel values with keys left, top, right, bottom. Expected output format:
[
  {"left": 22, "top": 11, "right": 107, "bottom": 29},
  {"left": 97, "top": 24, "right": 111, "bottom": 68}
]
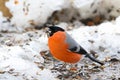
[{"left": 48, "top": 31, "right": 81, "bottom": 63}]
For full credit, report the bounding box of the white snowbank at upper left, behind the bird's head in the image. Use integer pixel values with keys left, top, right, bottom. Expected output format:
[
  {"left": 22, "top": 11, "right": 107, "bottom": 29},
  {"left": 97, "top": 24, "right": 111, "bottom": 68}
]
[{"left": 6, "top": 0, "right": 64, "bottom": 30}]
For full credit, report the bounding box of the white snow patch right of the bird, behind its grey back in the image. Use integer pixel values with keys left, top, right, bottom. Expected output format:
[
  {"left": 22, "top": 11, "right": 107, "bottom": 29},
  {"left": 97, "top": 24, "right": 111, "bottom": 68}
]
[{"left": 70, "top": 22, "right": 120, "bottom": 60}]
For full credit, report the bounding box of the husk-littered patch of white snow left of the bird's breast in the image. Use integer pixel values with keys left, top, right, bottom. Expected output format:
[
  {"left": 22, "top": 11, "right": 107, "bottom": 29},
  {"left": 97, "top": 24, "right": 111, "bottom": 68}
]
[{"left": 0, "top": 31, "right": 54, "bottom": 80}]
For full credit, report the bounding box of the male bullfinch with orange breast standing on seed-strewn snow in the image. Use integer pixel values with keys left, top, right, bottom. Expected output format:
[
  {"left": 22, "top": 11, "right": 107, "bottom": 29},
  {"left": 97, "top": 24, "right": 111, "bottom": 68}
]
[{"left": 47, "top": 26, "right": 103, "bottom": 65}]
